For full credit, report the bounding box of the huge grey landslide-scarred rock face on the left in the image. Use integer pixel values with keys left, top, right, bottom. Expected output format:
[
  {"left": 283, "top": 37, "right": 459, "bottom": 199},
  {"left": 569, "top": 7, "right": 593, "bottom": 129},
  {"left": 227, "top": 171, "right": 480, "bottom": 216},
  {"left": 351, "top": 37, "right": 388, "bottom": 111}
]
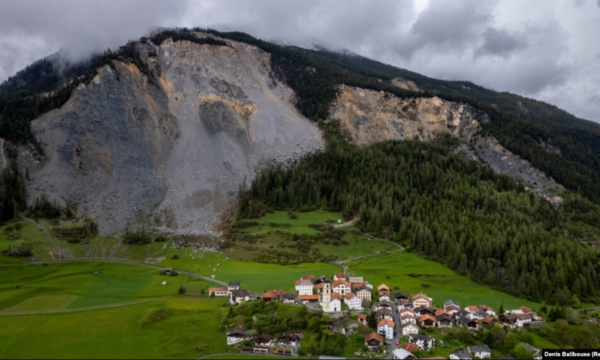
[{"left": 19, "top": 35, "right": 323, "bottom": 234}]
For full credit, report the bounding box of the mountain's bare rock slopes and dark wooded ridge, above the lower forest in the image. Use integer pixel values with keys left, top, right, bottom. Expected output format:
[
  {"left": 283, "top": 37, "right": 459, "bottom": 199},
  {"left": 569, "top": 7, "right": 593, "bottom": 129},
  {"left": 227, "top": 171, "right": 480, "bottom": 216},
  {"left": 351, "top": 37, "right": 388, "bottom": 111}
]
[{"left": 0, "top": 29, "right": 600, "bottom": 234}]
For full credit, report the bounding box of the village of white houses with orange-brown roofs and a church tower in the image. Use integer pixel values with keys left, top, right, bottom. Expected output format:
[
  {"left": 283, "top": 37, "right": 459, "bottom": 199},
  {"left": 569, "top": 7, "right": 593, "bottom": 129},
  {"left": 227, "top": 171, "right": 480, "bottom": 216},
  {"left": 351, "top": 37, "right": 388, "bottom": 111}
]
[{"left": 209, "top": 273, "right": 543, "bottom": 359}]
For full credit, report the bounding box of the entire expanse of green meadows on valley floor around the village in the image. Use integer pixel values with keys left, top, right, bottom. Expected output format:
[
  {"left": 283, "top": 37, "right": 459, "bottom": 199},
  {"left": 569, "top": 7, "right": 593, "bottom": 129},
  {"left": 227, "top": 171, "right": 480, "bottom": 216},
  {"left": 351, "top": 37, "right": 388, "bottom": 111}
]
[{"left": 0, "top": 212, "right": 592, "bottom": 358}]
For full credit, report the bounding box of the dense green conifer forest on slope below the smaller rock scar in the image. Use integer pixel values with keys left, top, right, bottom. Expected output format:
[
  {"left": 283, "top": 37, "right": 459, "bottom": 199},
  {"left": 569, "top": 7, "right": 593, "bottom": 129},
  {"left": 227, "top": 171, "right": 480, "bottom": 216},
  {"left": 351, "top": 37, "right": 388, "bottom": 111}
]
[{"left": 238, "top": 122, "right": 600, "bottom": 305}]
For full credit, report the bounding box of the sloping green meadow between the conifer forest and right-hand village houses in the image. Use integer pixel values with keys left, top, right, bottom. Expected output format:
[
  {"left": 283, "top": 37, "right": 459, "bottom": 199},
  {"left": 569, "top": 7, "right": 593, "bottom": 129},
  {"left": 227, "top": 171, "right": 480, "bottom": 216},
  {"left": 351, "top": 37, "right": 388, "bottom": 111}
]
[{"left": 347, "top": 252, "right": 540, "bottom": 311}]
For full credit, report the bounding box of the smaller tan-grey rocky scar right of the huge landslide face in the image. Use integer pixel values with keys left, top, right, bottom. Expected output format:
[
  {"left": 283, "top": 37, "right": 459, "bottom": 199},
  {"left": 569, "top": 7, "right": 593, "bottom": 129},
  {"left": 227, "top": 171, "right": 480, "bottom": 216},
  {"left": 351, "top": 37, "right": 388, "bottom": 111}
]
[{"left": 330, "top": 84, "right": 563, "bottom": 203}]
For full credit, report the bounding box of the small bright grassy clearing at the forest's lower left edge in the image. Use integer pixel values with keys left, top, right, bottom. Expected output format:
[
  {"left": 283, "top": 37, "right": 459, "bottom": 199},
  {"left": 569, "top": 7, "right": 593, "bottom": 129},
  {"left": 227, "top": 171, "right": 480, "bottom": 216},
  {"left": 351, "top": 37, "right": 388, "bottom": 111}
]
[{"left": 239, "top": 210, "right": 344, "bottom": 235}]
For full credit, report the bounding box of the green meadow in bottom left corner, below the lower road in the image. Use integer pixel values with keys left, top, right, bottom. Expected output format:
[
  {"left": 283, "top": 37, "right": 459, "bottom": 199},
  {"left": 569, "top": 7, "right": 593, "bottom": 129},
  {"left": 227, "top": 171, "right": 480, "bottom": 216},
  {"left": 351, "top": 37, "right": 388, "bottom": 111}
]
[{"left": 0, "top": 299, "right": 226, "bottom": 359}]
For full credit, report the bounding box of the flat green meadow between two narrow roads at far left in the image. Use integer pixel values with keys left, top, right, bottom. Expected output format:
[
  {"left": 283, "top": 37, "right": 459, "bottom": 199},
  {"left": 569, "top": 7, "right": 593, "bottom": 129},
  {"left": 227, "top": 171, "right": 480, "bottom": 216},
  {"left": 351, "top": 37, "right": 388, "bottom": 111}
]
[{"left": 0, "top": 262, "right": 191, "bottom": 314}]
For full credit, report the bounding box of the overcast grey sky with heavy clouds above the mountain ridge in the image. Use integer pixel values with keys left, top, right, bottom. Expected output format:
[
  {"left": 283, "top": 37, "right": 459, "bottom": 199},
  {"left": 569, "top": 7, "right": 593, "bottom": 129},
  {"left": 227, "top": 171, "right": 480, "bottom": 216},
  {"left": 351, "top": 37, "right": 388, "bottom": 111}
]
[{"left": 0, "top": 0, "right": 600, "bottom": 122}]
